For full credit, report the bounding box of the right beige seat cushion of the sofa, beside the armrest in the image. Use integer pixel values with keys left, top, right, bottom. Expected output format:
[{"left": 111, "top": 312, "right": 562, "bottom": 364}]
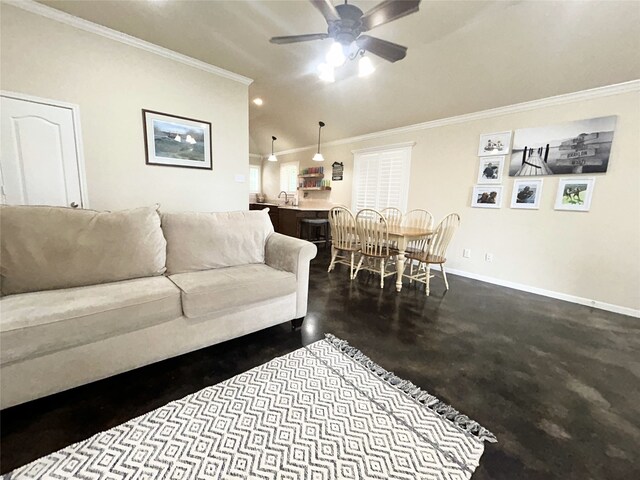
[{"left": 169, "top": 264, "right": 296, "bottom": 318}]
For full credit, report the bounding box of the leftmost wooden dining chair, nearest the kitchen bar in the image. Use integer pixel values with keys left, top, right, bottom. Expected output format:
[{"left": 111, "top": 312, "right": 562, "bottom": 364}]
[{"left": 327, "top": 206, "right": 360, "bottom": 280}]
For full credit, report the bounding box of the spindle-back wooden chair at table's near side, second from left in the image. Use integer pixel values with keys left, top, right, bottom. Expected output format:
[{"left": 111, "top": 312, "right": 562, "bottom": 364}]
[{"left": 353, "top": 208, "right": 398, "bottom": 288}]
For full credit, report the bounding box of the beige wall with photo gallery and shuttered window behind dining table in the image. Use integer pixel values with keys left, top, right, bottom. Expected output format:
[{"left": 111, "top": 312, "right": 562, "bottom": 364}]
[{"left": 263, "top": 88, "right": 640, "bottom": 310}]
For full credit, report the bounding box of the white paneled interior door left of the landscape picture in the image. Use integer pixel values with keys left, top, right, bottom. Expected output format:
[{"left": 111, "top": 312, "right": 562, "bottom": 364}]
[{"left": 0, "top": 94, "right": 86, "bottom": 208}]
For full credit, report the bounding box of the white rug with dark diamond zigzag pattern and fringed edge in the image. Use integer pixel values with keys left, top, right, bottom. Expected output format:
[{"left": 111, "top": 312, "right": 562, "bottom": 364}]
[{"left": 3, "top": 334, "right": 496, "bottom": 480}]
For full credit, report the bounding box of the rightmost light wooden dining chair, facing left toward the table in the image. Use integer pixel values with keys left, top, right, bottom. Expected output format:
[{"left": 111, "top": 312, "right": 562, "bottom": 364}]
[{"left": 404, "top": 213, "right": 460, "bottom": 296}]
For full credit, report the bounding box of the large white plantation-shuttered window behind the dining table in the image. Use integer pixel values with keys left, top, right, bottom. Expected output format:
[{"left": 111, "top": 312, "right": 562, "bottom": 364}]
[{"left": 351, "top": 144, "right": 413, "bottom": 212}]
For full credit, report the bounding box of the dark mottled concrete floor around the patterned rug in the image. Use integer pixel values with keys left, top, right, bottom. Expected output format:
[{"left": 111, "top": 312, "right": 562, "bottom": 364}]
[{"left": 0, "top": 251, "right": 640, "bottom": 480}]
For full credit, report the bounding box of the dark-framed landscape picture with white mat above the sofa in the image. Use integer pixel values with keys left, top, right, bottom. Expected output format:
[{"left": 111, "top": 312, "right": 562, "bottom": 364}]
[{"left": 142, "top": 110, "right": 213, "bottom": 170}]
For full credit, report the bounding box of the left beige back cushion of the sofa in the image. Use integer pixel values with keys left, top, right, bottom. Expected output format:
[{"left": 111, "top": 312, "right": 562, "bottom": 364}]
[{"left": 0, "top": 205, "right": 166, "bottom": 295}]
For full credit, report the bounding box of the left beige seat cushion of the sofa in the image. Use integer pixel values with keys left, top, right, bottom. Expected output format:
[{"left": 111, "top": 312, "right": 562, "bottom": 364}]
[{"left": 0, "top": 276, "right": 182, "bottom": 364}]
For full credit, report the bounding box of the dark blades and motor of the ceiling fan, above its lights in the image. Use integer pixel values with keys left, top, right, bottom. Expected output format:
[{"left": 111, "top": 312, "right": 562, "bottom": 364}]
[{"left": 270, "top": 0, "right": 421, "bottom": 62}]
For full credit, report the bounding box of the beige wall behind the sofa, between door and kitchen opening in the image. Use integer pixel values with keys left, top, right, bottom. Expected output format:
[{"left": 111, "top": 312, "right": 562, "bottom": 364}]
[{"left": 0, "top": 4, "right": 249, "bottom": 211}]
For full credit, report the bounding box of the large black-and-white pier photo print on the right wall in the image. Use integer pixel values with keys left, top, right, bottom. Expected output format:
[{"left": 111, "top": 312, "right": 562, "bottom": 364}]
[{"left": 509, "top": 115, "right": 618, "bottom": 177}]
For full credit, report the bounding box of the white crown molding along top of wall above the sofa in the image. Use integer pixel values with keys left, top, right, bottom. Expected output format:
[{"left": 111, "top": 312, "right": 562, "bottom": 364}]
[{"left": 2, "top": 0, "right": 253, "bottom": 85}]
